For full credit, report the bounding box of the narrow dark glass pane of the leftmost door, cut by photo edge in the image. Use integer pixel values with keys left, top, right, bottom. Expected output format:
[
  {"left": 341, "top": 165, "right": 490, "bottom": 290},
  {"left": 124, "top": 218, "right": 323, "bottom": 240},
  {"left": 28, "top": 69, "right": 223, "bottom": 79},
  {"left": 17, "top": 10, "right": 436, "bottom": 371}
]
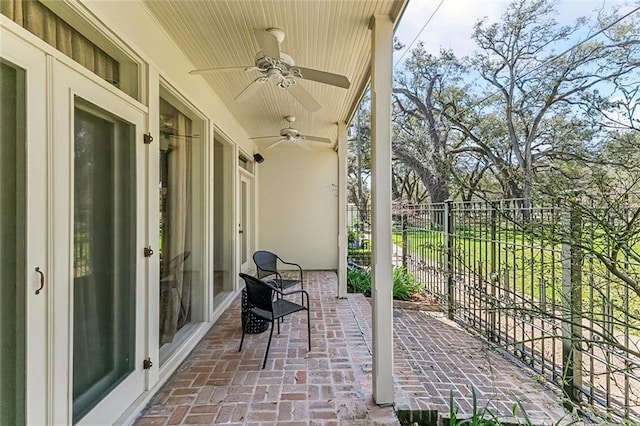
[{"left": 0, "top": 60, "right": 27, "bottom": 425}]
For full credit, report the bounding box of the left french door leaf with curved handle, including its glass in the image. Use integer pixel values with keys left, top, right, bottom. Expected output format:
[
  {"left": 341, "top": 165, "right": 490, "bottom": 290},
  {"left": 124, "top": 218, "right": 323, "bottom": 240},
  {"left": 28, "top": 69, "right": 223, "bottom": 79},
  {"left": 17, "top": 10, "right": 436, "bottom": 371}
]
[{"left": 0, "top": 30, "right": 52, "bottom": 425}]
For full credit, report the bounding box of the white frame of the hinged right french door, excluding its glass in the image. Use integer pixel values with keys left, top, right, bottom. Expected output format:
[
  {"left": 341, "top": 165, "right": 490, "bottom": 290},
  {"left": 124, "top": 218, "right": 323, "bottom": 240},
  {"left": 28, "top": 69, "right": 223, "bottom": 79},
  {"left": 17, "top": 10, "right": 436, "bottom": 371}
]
[{"left": 51, "top": 58, "right": 149, "bottom": 424}]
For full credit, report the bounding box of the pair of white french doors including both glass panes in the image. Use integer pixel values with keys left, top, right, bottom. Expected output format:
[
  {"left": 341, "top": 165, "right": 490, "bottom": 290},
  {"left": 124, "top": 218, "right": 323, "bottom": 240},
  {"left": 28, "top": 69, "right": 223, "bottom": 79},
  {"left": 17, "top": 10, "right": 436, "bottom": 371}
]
[{"left": 0, "top": 22, "right": 149, "bottom": 425}]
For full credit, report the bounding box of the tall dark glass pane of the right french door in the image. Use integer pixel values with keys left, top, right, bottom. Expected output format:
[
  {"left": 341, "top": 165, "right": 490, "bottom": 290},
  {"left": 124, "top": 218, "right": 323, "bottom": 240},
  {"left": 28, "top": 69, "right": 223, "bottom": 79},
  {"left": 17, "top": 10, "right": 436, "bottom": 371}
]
[{"left": 73, "top": 100, "right": 136, "bottom": 423}]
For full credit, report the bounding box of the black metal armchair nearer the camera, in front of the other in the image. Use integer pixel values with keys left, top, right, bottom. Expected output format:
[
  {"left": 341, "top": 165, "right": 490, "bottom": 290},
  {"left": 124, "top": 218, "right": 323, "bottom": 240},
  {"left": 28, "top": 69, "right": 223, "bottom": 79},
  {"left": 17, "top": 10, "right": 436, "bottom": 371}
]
[{"left": 238, "top": 273, "right": 311, "bottom": 369}]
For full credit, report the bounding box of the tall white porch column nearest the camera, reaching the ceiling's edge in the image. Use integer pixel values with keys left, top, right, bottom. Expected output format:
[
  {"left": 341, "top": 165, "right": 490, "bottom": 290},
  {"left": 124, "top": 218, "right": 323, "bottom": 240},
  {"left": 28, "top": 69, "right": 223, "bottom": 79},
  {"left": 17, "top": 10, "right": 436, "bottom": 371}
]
[{"left": 371, "top": 15, "right": 394, "bottom": 405}]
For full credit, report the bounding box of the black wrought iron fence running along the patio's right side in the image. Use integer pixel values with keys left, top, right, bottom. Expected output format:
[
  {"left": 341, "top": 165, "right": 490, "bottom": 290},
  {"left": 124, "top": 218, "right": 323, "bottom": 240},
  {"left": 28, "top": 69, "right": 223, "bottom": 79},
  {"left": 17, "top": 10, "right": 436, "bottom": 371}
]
[{"left": 349, "top": 200, "right": 640, "bottom": 423}]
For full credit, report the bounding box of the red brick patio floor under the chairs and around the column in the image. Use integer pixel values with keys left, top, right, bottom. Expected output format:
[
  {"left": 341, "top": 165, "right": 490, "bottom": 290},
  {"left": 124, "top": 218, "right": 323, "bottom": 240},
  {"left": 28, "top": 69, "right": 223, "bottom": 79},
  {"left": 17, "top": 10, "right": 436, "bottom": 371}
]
[{"left": 136, "top": 271, "right": 563, "bottom": 425}]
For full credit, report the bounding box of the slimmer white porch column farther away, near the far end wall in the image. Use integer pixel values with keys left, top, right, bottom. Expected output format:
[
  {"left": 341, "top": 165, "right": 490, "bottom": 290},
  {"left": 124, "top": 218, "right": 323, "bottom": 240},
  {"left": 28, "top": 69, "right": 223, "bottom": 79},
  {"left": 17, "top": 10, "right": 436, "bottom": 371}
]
[{"left": 338, "top": 123, "right": 347, "bottom": 298}]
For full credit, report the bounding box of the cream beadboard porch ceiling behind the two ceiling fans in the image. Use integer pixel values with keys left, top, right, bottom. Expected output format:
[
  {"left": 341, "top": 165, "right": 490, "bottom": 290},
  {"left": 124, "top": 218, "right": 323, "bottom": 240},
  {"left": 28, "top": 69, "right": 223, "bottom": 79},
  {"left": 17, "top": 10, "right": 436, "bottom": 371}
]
[{"left": 142, "top": 0, "right": 409, "bottom": 149}]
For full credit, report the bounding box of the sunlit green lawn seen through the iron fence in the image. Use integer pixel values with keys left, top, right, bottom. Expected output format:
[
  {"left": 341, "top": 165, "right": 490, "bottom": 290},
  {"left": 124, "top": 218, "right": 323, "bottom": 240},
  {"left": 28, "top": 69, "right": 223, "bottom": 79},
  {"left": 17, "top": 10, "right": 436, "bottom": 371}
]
[{"left": 392, "top": 229, "right": 640, "bottom": 334}]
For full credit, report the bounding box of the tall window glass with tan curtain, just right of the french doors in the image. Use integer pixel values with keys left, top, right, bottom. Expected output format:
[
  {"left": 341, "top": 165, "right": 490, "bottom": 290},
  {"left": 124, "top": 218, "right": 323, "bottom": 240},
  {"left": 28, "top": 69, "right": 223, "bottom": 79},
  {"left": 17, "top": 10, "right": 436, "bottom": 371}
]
[{"left": 158, "top": 95, "right": 204, "bottom": 352}]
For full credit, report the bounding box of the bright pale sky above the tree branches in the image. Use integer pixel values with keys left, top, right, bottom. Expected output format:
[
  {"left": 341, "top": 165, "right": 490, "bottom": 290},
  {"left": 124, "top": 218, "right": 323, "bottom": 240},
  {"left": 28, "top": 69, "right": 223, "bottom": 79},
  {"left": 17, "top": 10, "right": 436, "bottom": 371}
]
[{"left": 394, "top": 0, "right": 638, "bottom": 62}]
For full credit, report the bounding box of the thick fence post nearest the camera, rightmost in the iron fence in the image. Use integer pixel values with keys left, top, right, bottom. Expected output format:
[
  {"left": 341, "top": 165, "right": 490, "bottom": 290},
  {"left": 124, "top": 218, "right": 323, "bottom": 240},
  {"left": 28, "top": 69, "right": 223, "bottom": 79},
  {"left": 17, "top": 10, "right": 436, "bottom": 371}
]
[{"left": 562, "top": 209, "right": 582, "bottom": 408}]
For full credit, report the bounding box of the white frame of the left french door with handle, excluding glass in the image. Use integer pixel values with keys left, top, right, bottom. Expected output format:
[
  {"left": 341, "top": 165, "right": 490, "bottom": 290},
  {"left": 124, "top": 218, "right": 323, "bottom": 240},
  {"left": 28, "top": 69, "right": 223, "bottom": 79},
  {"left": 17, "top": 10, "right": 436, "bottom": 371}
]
[{"left": 0, "top": 32, "right": 53, "bottom": 424}]
